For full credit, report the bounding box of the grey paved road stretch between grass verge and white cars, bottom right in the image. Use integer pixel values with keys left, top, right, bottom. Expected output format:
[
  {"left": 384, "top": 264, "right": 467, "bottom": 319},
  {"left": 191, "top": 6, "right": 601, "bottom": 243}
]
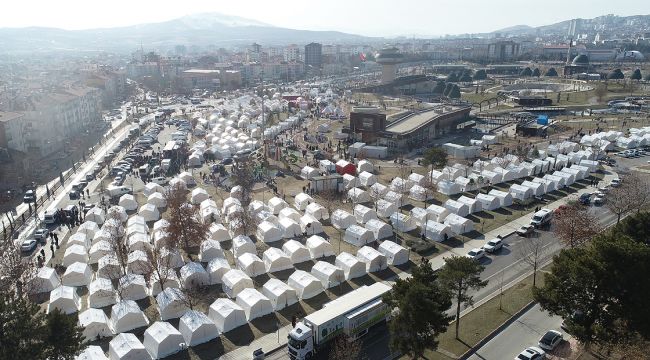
[{"left": 469, "top": 305, "right": 570, "bottom": 360}]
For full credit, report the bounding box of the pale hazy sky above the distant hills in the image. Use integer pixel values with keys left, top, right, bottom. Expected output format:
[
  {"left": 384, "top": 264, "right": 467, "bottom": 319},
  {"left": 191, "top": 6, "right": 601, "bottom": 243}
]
[{"left": 0, "top": 0, "right": 650, "bottom": 36}]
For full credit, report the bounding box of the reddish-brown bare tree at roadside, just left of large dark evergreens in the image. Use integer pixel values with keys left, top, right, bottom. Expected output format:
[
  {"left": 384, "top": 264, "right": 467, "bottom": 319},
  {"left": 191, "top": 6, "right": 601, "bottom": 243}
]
[{"left": 553, "top": 202, "right": 601, "bottom": 248}]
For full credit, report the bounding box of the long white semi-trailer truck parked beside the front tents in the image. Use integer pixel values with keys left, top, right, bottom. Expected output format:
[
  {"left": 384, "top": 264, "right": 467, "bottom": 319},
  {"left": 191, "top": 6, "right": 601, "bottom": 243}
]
[{"left": 287, "top": 283, "right": 391, "bottom": 360}]
